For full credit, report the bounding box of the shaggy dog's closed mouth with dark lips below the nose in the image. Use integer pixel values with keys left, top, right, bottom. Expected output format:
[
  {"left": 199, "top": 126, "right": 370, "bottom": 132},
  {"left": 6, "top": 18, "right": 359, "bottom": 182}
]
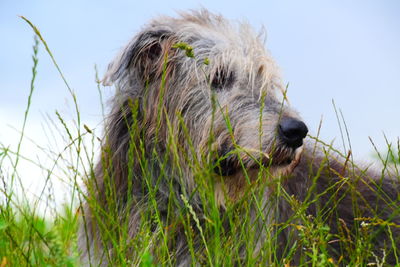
[{"left": 214, "top": 146, "right": 303, "bottom": 176}]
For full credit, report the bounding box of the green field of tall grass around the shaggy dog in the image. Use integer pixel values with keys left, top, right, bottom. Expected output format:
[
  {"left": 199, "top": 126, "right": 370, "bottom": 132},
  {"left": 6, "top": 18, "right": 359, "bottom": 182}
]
[{"left": 0, "top": 21, "right": 400, "bottom": 267}]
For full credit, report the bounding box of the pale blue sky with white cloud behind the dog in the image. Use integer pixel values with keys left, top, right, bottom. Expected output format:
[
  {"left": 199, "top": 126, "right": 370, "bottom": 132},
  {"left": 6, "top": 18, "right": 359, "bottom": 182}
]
[{"left": 0, "top": 0, "right": 400, "bottom": 205}]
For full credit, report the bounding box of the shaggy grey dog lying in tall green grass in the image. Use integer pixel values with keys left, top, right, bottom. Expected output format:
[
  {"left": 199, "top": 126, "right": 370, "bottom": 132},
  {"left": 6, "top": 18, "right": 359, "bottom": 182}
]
[{"left": 79, "top": 10, "right": 400, "bottom": 266}]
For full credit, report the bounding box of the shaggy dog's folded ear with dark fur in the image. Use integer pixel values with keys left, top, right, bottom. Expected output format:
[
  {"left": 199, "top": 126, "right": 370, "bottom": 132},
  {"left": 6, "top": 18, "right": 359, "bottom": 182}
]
[{"left": 103, "top": 29, "right": 176, "bottom": 89}]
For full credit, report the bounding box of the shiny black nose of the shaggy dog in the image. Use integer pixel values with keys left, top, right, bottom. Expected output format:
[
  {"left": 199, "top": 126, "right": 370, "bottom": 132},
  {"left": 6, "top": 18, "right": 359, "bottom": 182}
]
[{"left": 278, "top": 117, "right": 308, "bottom": 148}]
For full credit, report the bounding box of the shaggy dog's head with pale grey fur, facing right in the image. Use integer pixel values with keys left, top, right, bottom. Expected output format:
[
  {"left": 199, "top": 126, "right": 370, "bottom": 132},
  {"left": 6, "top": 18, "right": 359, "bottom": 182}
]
[{"left": 105, "top": 12, "right": 308, "bottom": 184}]
